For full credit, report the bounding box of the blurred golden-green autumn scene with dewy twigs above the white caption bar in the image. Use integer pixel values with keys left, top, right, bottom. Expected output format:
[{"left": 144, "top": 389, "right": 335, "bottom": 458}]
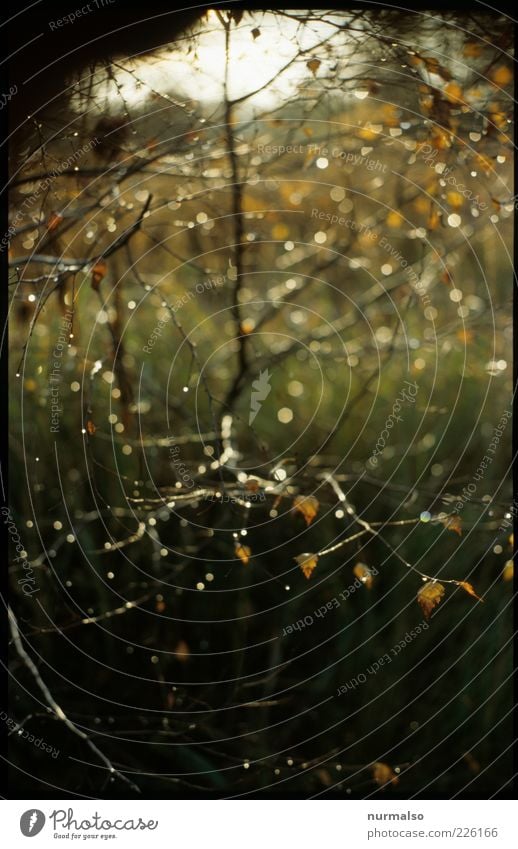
[{"left": 4, "top": 8, "right": 515, "bottom": 799}]
